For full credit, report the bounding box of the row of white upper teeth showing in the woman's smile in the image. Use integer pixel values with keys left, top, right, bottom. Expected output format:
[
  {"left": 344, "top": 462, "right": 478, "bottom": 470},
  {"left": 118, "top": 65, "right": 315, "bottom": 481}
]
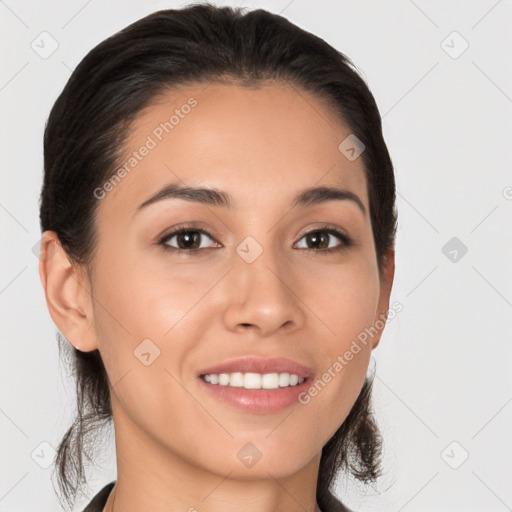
[{"left": 203, "top": 372, "right": 305, "bottom": 389}]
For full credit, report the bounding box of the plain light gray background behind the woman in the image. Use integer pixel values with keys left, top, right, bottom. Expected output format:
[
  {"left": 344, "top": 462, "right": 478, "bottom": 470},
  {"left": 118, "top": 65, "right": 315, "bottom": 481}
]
[{"left": 0, "top": 0, "right": 512, "bottom": 512}]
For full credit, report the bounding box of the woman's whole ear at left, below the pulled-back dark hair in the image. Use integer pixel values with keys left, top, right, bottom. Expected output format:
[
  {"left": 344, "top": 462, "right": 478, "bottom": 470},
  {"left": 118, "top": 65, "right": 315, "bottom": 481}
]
[{"left": 39, "top": 231, "right": 97, "bottom": 352}]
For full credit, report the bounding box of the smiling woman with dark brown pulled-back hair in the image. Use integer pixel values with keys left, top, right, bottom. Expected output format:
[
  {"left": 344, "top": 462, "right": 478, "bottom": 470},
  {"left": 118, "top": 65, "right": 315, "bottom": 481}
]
[{"left": 40, "top": 4, "right": 397, "bottom": 512}]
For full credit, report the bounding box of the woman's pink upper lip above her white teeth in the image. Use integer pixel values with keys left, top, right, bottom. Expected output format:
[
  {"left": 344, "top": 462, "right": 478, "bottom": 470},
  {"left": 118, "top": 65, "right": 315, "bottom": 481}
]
[{"left": 199, "top": 357, "right": 313, "bottom": 379}]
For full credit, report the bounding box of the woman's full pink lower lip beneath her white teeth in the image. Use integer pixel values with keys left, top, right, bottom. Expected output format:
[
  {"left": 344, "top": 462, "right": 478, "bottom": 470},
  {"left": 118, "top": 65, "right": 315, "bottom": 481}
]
[{"left": 200, "top": 378, "right": 311, "bottom": 414}]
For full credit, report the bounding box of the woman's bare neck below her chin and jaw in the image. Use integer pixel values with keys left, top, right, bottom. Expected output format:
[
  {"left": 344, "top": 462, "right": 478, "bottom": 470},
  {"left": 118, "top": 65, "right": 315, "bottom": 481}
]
[{"left": 104, "top": 400, "right": 321, "bottom": 512}]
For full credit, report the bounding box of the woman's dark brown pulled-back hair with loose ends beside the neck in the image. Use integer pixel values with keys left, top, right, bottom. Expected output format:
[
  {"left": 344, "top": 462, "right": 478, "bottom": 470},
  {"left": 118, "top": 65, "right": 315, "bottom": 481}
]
[{"left": 40, "top": 4, "right": 397, "bottom": 507}]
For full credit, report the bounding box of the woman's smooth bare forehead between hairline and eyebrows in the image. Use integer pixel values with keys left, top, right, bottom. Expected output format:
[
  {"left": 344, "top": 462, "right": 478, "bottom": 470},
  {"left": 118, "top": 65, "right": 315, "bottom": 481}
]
[{"left": 96, "top": 83, "right": 367, "bottom": 220}]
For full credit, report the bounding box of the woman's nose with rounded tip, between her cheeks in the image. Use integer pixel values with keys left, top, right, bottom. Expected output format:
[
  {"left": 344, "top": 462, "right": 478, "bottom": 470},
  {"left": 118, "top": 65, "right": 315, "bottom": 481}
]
[{"left": 224, "top": 243, "right": 304, "bottom": 336}]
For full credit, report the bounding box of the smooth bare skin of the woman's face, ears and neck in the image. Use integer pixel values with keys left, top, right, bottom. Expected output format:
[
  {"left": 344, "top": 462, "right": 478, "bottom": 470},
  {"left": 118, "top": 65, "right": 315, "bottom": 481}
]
[{"left": 40, "top": 82, "right": 394, "bottom": 512}]
